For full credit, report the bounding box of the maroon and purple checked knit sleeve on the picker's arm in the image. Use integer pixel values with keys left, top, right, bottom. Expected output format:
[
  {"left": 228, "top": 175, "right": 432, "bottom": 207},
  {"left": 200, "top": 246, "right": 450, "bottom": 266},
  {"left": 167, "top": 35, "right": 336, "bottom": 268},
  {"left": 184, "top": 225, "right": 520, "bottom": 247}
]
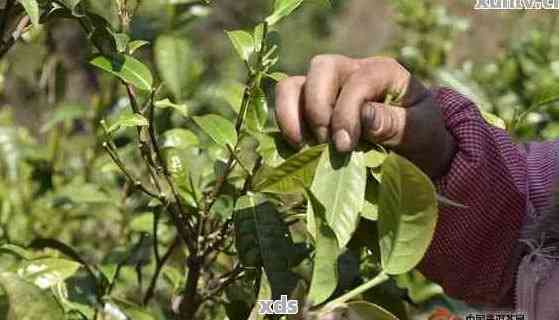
[{"left": 420, "top": 88, "right": 557, "bottom": 305}]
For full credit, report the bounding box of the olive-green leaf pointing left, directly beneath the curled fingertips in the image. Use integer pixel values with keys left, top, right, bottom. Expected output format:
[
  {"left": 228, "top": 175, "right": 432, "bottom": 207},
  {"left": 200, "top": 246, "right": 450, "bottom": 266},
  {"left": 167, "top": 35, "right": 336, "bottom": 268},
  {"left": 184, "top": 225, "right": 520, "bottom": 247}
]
[{"left": 254, "top": 145, "right": 326, "bottom": 193}]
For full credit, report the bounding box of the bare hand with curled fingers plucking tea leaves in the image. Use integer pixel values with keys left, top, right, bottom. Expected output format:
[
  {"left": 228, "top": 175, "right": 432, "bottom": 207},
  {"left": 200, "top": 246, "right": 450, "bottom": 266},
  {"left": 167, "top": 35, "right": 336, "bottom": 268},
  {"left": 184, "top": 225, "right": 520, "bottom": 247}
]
[{"left": 276, "top": 55, "right": 455, "bottom": 178}]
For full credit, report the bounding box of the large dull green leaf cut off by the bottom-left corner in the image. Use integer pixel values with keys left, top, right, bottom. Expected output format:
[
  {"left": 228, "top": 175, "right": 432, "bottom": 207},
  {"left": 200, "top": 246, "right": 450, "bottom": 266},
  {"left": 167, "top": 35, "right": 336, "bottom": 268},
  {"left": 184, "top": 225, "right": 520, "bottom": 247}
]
[{"left": 0, "top": 272, "right": 64, "bottom": 320}]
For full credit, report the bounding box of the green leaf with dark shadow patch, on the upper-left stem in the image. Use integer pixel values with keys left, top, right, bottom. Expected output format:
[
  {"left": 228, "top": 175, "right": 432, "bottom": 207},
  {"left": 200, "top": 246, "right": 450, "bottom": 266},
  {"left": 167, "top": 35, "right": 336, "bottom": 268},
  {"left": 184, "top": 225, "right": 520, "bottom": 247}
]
[{"left": 90, "top": 54, "right": 153, "bottom": 91}]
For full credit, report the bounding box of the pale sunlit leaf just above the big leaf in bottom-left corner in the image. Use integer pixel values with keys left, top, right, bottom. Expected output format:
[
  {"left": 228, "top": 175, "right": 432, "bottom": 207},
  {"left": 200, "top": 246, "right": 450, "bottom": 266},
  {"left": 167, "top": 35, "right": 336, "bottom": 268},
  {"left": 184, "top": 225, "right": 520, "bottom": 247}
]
[{"left": 17, "top": 258, "right": 81, "bottom": 289}]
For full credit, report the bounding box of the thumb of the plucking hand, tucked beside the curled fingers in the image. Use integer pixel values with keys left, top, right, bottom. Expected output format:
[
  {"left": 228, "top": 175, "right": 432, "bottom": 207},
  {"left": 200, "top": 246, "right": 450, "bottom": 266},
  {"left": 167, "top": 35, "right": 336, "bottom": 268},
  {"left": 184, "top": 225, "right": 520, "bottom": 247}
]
[{"left": 361, "top": 102, "right": 407, "bottom": 147}]
